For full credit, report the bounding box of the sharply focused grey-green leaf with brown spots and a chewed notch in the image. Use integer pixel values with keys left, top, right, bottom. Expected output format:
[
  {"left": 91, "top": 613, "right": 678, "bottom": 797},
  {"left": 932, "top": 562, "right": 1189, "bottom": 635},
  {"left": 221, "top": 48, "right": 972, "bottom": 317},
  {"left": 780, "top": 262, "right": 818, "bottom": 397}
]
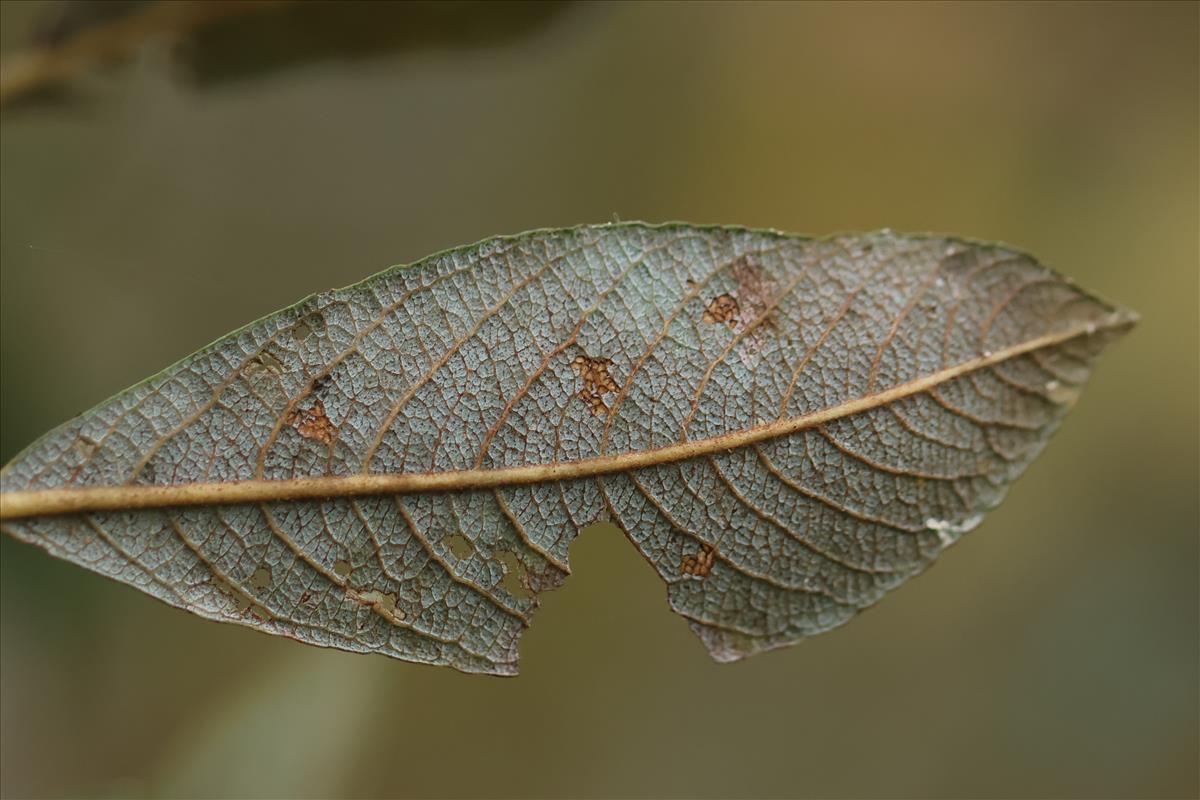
[{"left": 0, "top": 224, "right": 1136, "bottom": 674}]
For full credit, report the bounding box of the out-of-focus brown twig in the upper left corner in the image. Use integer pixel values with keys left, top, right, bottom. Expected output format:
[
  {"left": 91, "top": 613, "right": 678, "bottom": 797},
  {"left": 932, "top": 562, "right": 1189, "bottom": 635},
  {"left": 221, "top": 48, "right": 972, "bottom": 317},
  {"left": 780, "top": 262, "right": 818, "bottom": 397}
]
[{"left": 0, "top": 0, "right": 290, "bottom": 106}]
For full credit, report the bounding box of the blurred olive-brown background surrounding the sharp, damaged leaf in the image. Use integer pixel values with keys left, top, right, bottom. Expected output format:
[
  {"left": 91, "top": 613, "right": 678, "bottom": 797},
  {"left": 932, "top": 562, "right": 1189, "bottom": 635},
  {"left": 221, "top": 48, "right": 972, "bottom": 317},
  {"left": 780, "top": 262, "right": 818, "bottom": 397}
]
[{"left": 0, "top": 1, "right": 1200, "bottom": 798}]
